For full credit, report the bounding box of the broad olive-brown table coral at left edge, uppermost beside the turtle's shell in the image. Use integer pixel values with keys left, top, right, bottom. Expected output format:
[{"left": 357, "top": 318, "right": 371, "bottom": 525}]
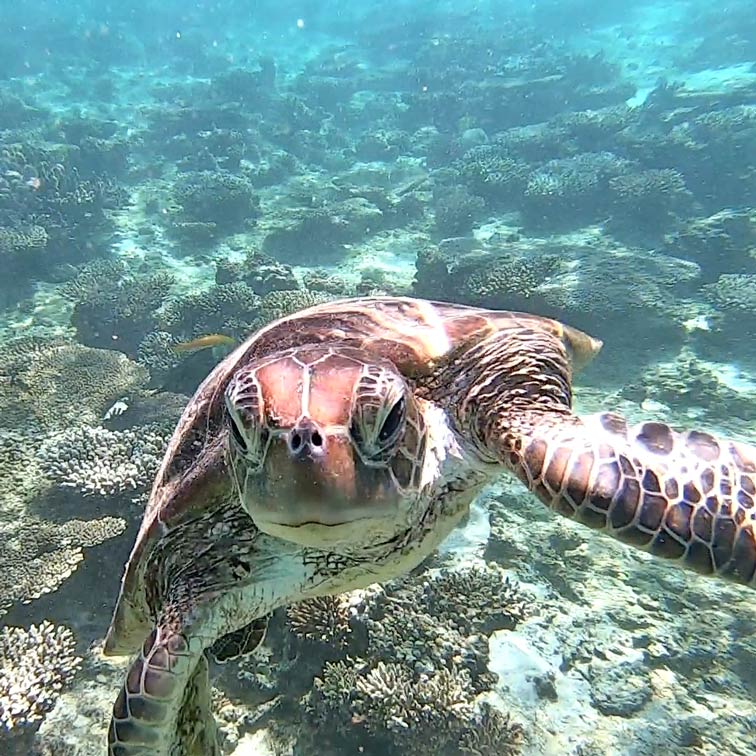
[{"left": 0, "top": 338, "right": 149, "bottom": 430}]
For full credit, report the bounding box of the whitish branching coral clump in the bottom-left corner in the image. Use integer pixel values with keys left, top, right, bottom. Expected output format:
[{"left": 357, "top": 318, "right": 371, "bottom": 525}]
[{"left": 0, "top": 620, "right": 81, "bottom": 742}]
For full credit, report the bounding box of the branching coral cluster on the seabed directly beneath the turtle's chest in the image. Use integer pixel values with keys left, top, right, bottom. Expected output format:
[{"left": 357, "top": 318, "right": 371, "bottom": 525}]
[{"left": 227, "top": 564, "right": 533, "bottom": 754}]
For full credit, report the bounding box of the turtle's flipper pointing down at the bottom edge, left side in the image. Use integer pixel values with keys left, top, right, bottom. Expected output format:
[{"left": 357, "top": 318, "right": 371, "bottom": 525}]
[{"left": 108, "top": 625, "right": 220, "bottom": 756}]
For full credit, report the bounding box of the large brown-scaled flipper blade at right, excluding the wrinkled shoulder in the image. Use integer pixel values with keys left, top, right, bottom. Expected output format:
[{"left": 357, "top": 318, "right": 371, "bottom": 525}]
[{"left": 499, "top": 412, "right": 756, "bottom": 587}]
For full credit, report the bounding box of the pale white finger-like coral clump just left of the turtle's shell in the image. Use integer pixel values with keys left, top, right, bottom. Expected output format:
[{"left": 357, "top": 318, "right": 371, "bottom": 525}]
[{"left": 38, "top": 425, "right": 172, "bottom": 496}]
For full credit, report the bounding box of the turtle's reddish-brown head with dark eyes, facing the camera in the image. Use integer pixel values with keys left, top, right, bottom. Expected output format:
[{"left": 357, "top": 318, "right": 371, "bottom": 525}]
[{"left": 225, "top": 345, "right": 426, "bottom": 550}]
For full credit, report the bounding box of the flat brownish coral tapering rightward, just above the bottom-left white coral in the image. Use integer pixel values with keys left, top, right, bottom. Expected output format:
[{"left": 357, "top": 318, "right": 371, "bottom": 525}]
[{"left": 0, "top": 516, "right": 126, "bottom": 616}]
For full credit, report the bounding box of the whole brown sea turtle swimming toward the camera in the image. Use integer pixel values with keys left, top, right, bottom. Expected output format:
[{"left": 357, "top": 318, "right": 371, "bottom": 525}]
[{"left": 105, "top": 297, "right": 756, "bottom": 756}]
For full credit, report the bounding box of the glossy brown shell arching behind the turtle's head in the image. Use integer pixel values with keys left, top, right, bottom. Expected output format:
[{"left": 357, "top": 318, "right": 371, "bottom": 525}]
[{"left": 105, "top": 297, "right": 601, "bottom": 654}]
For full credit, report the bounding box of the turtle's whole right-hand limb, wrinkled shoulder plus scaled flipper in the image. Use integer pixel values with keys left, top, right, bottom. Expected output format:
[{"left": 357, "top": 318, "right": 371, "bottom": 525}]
[{"left": 456, "top": 324, "right": 756, "bottom": 586}]
